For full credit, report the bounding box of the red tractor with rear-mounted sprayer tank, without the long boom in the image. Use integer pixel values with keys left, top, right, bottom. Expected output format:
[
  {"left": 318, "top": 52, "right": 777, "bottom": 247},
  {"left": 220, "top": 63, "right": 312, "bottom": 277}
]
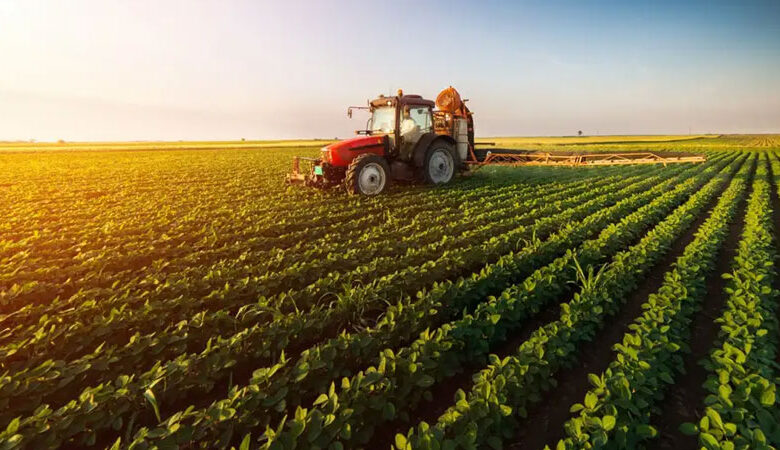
[{"left": 287, "top": 87, "right": 474, "bottom": 195}]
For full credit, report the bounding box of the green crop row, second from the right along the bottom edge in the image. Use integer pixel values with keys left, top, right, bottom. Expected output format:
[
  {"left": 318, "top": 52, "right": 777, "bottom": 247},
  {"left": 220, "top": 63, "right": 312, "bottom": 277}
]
[{"left": 557, "top": 154, "right": 752, "bottom": 449}]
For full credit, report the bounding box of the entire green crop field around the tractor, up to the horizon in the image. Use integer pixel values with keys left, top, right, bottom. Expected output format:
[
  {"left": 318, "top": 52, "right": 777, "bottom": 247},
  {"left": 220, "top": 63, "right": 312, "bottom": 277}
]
[{"left": 0, "top": 135, "right": 780, "bottom": 450}]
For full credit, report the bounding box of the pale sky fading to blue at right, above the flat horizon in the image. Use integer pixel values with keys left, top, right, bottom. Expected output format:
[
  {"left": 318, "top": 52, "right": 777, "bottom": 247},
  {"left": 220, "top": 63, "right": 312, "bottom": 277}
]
[{"left": 0, "top": 0, "right": 780, "bottom": 140}]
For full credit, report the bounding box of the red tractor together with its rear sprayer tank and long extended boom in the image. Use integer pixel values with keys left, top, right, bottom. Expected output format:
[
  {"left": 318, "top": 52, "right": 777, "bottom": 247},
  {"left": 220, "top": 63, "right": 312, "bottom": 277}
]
[{"left": 287, "top": 86, "right": 707, "bottom": 195}]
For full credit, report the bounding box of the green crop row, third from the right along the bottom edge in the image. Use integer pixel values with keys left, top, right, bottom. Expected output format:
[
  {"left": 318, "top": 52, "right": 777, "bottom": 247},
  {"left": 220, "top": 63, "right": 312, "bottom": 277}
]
[{"left": 395, "top": 156, "right": 748, "bottom": 449}]
